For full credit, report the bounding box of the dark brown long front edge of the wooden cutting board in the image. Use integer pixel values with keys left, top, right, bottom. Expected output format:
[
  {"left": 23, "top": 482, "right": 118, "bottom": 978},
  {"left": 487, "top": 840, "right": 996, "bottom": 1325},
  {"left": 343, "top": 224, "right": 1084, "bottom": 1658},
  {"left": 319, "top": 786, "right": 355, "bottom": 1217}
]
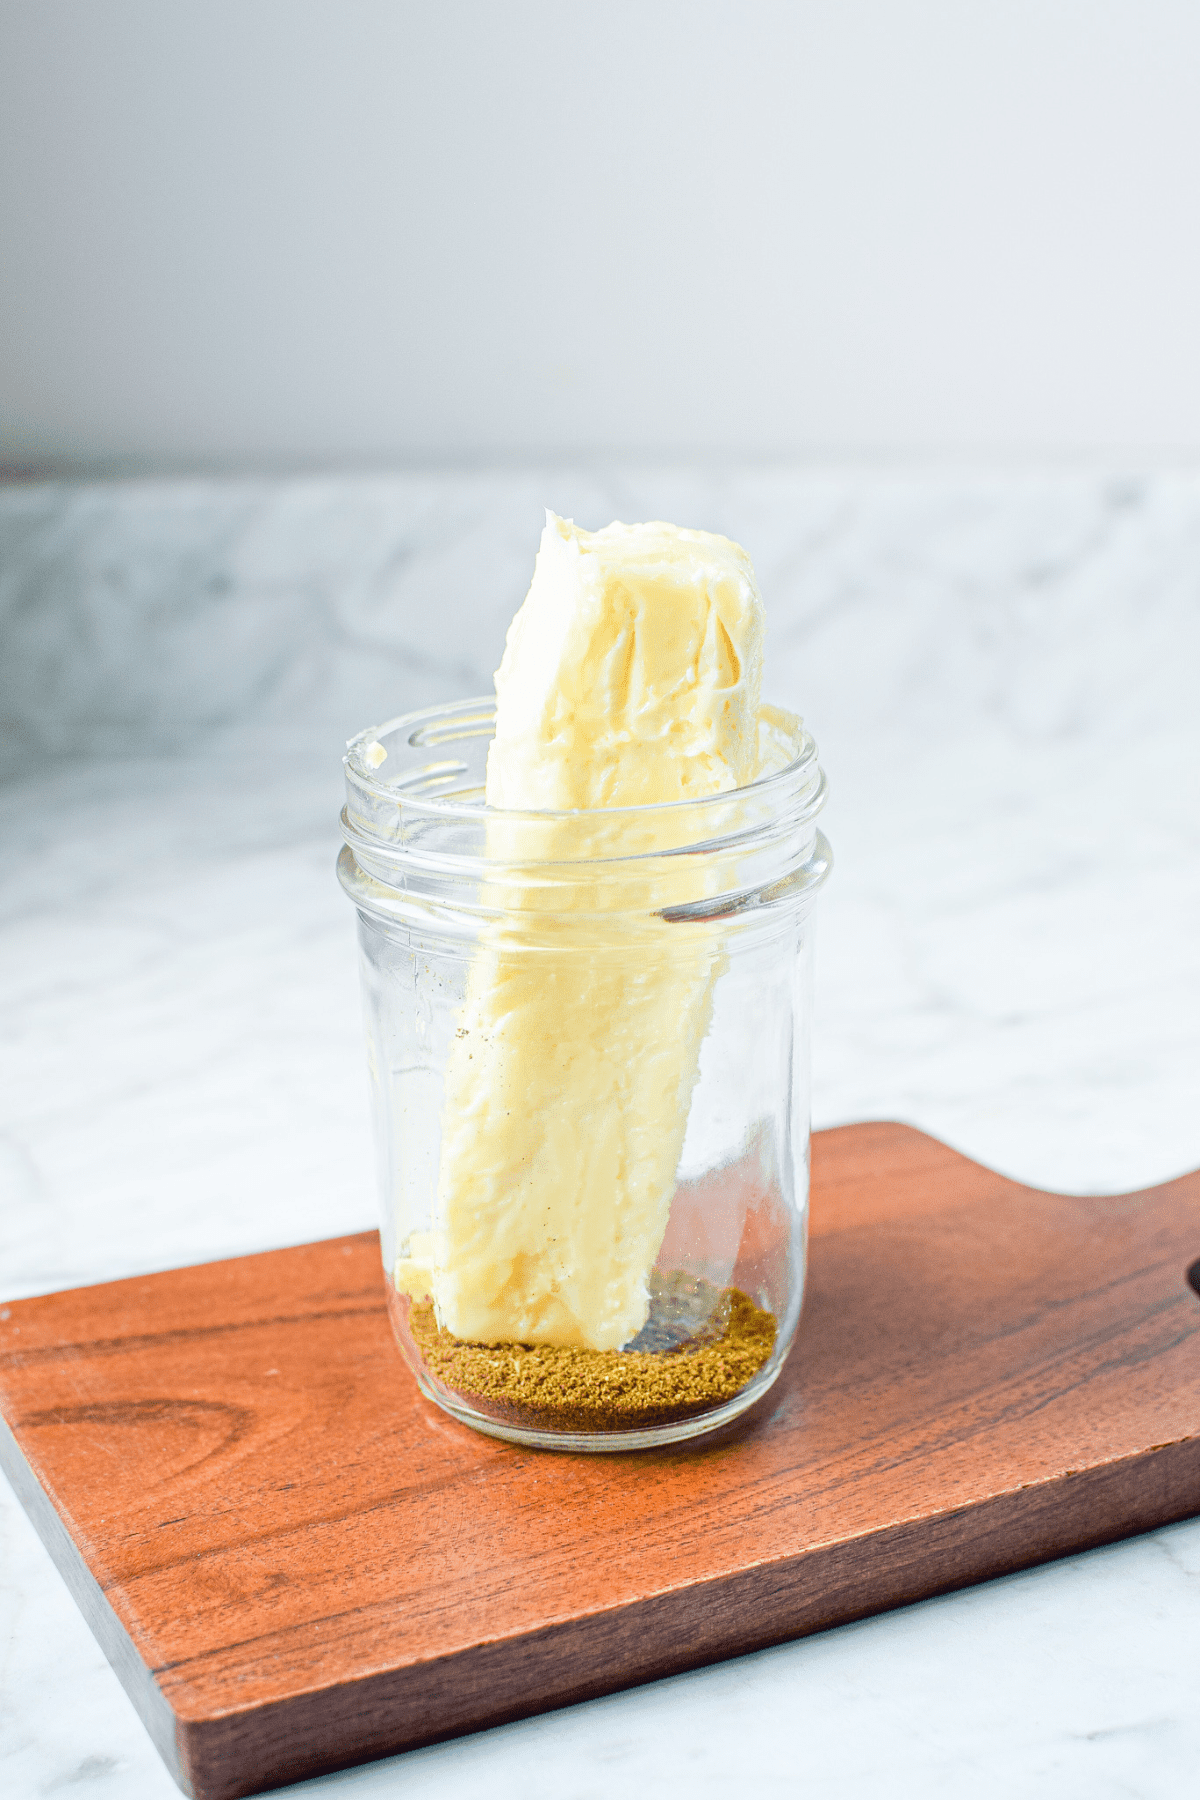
[{"left": 169, "top": 1436, "right": 1200, "bottom": 1800}]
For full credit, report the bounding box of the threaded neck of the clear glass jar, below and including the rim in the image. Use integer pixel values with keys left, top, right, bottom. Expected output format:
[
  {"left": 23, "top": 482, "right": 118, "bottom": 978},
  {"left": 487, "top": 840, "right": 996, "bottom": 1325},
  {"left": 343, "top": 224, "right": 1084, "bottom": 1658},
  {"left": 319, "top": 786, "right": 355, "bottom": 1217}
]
[{"left": 338, "top": 697, "right": 829, "bottom": 918}]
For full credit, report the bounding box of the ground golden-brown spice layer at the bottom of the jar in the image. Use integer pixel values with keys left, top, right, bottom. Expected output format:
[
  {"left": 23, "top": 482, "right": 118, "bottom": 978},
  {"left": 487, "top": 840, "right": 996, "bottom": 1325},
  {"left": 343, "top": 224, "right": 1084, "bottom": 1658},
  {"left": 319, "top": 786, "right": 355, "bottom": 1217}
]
[{"left": 389, "top": 1273, "right": 777, "bottom": 1449}]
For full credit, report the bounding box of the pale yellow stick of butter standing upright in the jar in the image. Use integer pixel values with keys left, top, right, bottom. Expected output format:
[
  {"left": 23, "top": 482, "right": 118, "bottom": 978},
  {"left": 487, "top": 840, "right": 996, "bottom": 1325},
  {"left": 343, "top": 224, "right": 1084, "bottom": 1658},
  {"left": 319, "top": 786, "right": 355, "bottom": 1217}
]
[{"left": 396, "top": 515, "right": 763, "bottom": 1350}]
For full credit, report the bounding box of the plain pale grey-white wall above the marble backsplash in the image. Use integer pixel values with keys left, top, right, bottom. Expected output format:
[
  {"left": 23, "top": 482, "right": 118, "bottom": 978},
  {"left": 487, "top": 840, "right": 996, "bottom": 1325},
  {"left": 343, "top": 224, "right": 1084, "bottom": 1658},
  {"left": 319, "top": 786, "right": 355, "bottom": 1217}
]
[{"left": 0, "top": 0, "right": 1200, "bottom": 470}]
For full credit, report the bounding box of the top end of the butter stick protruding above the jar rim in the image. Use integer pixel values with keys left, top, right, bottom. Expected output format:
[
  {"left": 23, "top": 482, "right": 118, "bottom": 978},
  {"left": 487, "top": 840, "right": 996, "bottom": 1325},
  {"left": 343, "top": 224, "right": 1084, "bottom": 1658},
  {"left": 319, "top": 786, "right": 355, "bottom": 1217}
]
[{"left": 488, "top": 515, "right": 763, "bottom": 812}]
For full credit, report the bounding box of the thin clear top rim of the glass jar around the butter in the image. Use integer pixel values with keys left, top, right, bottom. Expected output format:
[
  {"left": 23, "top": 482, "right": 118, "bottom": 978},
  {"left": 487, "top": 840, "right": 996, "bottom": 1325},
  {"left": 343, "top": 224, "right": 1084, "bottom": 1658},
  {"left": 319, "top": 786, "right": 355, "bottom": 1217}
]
[{"left": 342, "top": 695, "right": 826, "bottom": 837}]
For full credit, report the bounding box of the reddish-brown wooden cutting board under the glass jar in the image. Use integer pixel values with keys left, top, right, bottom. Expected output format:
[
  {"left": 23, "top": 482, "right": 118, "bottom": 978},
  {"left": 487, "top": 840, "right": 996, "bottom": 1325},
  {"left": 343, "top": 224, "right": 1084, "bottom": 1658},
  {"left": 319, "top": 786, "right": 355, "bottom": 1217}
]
[{"left": 0, "top": 1125, "right": 1200, "bottom": 1800}]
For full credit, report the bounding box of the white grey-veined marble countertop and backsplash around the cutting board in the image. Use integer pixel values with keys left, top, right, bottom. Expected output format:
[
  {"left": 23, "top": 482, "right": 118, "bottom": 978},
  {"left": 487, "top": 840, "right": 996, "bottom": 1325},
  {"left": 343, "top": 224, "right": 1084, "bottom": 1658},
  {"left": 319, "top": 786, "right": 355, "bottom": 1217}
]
[{"left": 0, "top": 468, "right": 1200, "bottom": 1800}]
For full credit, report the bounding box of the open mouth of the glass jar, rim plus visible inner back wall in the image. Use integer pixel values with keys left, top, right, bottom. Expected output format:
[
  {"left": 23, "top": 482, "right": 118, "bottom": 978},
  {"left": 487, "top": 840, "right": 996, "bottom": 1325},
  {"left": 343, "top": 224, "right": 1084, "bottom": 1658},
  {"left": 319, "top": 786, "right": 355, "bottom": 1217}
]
[{"left": 342, "top": 695, "right": 826, "bottom": 844}]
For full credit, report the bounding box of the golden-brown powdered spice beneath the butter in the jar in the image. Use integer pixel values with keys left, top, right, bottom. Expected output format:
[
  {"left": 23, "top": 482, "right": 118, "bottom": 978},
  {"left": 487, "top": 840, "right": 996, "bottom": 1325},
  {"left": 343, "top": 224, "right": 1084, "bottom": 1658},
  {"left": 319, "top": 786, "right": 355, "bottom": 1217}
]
[{"left": 408, "top": 1276, "right": 775, "bottom": 1431}]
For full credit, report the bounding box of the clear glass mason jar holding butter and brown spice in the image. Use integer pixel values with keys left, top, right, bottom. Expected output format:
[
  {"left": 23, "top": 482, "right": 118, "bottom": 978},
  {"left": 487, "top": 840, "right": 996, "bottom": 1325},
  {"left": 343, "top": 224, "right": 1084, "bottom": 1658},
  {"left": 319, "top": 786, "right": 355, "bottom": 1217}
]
[{"left": 338, "top": 700, "right": 831, "bottom": 1451}]
